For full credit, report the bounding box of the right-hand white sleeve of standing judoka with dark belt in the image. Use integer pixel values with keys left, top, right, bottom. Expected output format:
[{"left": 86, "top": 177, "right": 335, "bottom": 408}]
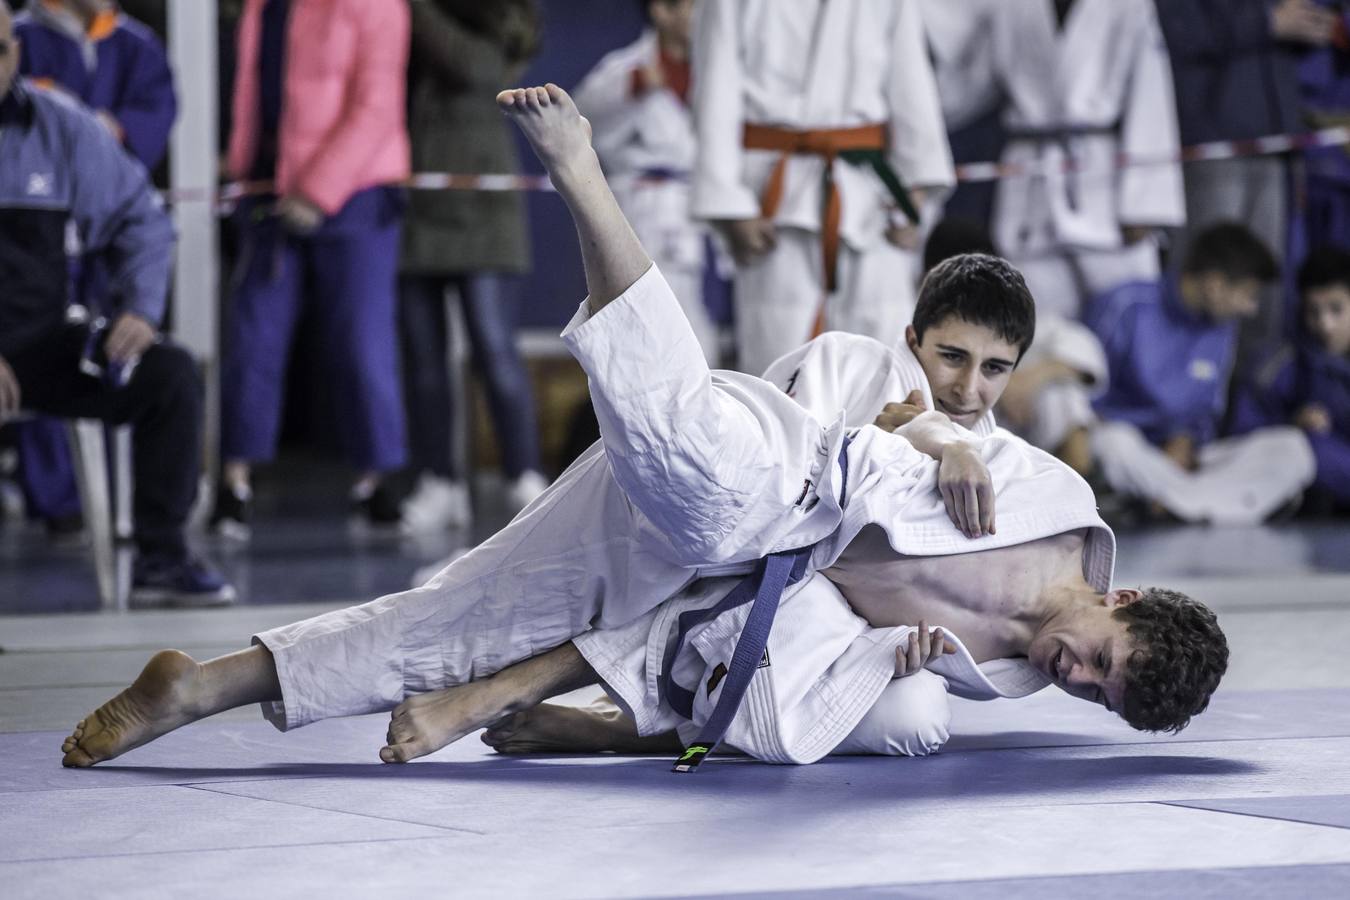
[{"left": 1116, "top": 0, "right": 1185, "bottom": 225}]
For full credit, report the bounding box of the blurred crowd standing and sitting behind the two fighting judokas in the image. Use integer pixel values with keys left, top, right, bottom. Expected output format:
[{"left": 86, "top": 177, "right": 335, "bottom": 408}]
[{"left": 0, "top": 0, "right": 1350, "bottom": 602}]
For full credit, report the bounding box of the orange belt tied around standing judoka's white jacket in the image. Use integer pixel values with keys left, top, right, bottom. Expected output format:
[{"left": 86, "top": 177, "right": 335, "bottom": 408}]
[{"left": 744, "top": 124, "right": 886, "bottom": 337}]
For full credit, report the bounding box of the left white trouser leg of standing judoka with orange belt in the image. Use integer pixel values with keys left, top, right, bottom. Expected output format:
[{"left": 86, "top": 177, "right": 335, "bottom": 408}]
[{"left": 733, "top": 228, "right": 820, "bottom": 375}]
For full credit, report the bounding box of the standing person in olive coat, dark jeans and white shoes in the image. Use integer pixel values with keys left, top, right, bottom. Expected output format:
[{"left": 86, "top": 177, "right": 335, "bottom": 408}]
[{"left": 400, "top": 0, "right": 548, "bottom": 532}]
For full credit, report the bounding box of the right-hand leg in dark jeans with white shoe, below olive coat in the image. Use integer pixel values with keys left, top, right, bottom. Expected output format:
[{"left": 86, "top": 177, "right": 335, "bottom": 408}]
[{"left": 456, "top": 273, "right": 548, "bottom": 509}]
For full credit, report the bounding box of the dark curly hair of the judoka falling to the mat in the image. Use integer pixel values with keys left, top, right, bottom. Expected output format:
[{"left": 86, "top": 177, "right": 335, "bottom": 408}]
[{"left": 1112, "top": 587, "right": 1229, "bottom": 733}]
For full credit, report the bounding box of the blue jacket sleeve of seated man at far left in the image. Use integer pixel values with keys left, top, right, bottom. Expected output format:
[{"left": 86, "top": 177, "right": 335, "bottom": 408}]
[{"left": 62, "top": 105, "right": 174, "bottom": 325}]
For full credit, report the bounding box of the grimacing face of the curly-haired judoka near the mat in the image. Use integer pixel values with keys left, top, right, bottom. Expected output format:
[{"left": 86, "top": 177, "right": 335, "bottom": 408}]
[{"left": 1027, "top": 590, "right": 1141, "bottom": 712}]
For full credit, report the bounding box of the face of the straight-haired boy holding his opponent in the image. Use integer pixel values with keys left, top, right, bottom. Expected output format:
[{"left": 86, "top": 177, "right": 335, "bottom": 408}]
[{"left": 905, "top": 316, "right": 1019, "bottom": 428}]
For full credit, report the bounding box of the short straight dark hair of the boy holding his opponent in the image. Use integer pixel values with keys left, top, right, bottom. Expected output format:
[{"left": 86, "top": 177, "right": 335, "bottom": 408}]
[{"left": 914, "top": 254, "right": 1035, "bottom": 359}]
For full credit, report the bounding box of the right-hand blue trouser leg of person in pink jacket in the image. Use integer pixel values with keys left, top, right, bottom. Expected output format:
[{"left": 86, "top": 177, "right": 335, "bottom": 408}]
[{"left": 305, "top": 188, "right": 406, "bottom": 472}]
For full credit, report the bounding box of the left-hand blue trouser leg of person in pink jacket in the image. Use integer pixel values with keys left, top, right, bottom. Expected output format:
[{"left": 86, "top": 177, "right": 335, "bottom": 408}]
[{"left": 220, "top": 207, "right": 304, "bottom": 463}]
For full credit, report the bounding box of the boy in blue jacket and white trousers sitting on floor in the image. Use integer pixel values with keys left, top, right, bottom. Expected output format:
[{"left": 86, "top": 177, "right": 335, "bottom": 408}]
[{"left": 1087, "top": 224, "right": 1314, "bottom": 524}]
